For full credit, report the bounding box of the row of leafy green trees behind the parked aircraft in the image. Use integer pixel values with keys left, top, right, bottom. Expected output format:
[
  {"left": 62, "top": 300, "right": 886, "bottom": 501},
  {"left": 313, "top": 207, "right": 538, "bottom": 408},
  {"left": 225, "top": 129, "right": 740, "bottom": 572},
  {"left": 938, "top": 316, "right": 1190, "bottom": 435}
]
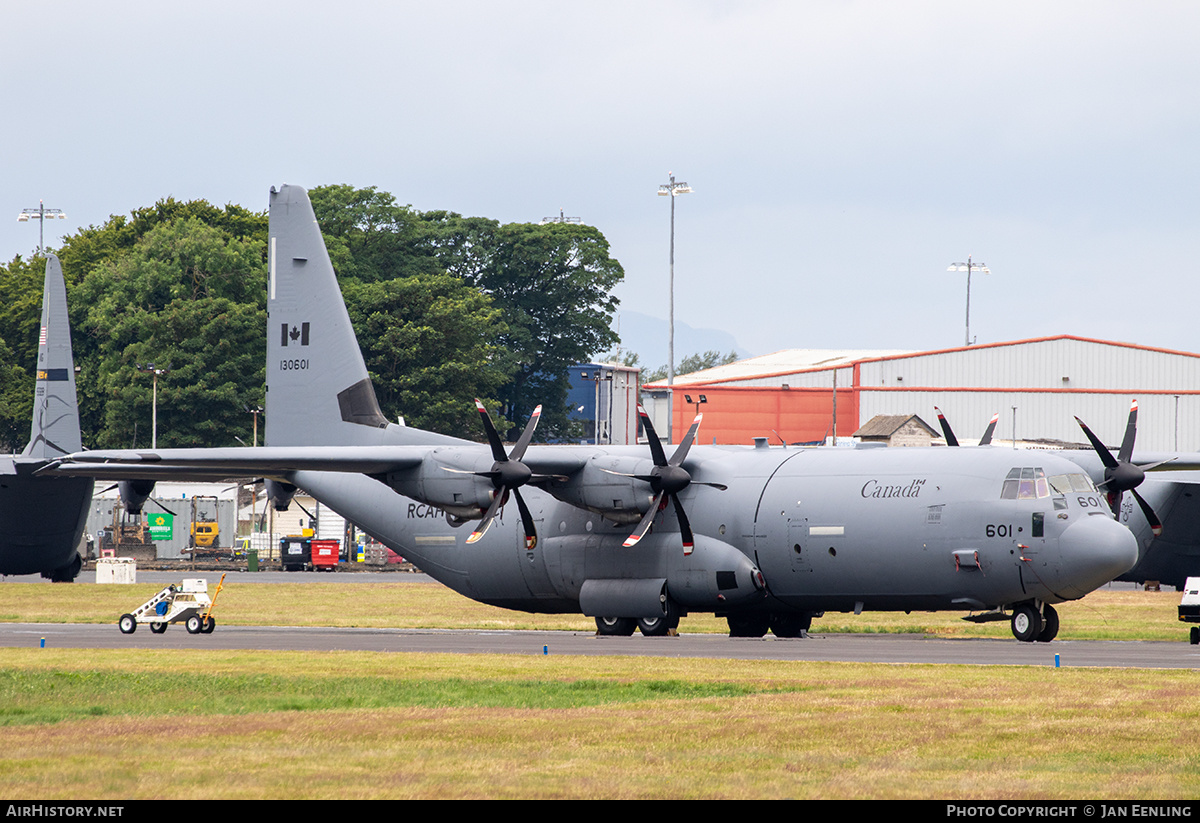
[{"left": 0, "top": 186, "right": 624, "bottom": 451}]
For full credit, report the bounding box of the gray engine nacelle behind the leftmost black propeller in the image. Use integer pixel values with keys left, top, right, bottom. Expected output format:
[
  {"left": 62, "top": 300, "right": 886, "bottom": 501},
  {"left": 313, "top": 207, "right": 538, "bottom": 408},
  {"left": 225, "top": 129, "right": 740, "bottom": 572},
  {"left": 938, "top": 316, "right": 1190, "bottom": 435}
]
[{"left": 386, "top": 449, "right": 496, "bottom": 519}]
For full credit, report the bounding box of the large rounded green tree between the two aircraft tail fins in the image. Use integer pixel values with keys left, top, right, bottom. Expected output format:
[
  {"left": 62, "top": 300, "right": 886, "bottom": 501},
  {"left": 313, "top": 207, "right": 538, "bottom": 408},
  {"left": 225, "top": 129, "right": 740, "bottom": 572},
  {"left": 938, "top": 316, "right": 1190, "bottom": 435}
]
[{"left": 74, "top": 216, "right": 266, "bottom": 447}]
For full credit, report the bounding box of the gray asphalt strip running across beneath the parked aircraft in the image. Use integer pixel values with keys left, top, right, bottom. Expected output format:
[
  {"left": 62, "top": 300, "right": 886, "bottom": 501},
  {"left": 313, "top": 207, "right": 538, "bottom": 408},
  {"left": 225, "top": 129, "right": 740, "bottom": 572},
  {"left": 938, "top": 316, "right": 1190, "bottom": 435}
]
[{"left": 0, "top": 620, "right": 1200, "bottom": 668}]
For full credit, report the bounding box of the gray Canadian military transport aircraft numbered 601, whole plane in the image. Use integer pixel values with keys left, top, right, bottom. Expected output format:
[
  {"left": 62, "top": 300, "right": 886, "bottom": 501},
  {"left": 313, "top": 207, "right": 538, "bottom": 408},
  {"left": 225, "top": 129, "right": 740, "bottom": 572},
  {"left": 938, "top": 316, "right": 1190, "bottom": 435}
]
[{"left": 42, "top": 186, "right": 1138, "bottom": 641}]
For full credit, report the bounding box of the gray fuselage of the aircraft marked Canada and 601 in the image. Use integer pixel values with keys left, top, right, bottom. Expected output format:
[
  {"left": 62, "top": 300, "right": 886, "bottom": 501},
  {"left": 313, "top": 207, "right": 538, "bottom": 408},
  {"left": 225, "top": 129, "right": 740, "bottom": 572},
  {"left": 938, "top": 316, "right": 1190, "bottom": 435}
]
[{"left": 288, "top": 446, "right": 1136, "bottom": 617}]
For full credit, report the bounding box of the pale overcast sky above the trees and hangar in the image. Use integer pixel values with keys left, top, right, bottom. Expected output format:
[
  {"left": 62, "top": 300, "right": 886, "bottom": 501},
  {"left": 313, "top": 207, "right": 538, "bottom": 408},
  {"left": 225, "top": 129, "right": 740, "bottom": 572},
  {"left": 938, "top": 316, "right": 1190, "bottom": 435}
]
[{"left": 0, "top": 0, "right": 1200, "bottom": 356}]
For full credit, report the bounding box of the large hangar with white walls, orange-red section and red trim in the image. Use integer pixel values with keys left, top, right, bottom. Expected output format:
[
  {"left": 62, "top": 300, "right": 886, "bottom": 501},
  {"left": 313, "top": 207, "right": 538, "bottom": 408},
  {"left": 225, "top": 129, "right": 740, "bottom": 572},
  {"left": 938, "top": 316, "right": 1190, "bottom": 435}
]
[{"left": 643, "top": 335, "right": 1200, "bottom": 451}]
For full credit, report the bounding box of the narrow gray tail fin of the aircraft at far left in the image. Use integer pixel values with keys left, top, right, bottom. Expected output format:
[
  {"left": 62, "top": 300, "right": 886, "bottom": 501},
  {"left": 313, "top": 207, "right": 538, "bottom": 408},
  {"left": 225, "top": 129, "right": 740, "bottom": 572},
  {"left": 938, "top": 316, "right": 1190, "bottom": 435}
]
[{"left": 22, "top": 254, "right": 83, "bottom": 459}]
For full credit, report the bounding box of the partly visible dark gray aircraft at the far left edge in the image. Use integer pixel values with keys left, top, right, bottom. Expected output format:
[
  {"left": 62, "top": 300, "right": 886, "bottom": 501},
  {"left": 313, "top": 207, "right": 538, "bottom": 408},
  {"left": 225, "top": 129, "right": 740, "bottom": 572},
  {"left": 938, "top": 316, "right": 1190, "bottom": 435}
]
[{"left": 0, "top": 254, "right": 94, "bottom": 581}]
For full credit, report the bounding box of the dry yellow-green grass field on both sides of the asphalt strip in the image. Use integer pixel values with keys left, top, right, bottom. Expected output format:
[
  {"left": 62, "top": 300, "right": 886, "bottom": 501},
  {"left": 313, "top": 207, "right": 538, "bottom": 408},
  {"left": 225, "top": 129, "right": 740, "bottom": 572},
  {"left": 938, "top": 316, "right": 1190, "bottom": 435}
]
[{"left": 0, "top": 578, "right": 1200, "bottom": 800}]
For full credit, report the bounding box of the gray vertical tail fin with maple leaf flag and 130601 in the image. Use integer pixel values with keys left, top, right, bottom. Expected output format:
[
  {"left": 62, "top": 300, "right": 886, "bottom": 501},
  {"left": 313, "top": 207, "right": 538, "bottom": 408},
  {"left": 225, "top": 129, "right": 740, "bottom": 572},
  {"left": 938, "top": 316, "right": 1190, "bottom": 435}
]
[{"left": 266, "top": 185, "right": 450, "bottom": 446}]
